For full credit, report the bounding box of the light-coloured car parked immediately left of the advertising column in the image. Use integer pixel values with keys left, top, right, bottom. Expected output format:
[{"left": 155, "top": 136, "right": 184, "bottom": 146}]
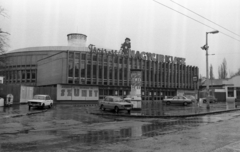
[{"left": 99, "top": 96, "right": 133, "bottom": 113}]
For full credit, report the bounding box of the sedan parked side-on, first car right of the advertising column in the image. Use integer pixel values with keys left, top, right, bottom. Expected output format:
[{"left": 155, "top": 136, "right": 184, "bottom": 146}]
[{"left": 163, "top": 96, "right": 194, "bottom": 106}]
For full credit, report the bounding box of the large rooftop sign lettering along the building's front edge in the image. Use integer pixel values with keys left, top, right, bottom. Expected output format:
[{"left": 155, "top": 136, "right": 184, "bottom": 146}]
[{"left": 88, "top": 45, "right": 186, "bottom": 65}]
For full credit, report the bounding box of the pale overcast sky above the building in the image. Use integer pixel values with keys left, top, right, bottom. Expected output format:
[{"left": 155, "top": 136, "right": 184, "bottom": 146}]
[{"left": 0, "top": 0, "right": 240, "bottom": 78}]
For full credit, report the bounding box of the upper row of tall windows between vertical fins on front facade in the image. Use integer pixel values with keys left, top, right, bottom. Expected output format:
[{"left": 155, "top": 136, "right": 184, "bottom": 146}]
[{"left": 68, "top": 64, "right": 197, "bottom": 83}]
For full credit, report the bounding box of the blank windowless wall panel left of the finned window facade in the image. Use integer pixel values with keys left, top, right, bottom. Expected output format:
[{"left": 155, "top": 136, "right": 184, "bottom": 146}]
[{"left": 37, "top": 52, "right": 67, "bottom": 86}]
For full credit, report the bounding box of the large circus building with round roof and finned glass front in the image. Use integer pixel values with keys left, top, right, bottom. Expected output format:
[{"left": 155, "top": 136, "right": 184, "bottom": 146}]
[{"left": 0, "top": 33, "right": 198, "bottom": 101}]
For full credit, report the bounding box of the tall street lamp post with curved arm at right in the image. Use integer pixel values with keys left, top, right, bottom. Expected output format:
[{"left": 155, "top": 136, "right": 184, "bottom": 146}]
[{"left": 201, "top": 30, "right": 219, "bottom": 109}]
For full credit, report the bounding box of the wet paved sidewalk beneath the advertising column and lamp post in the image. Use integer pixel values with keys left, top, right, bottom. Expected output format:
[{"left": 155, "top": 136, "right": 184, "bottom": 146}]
[{"left": 91, "top": 102, "right": 240, "bottom": 118}]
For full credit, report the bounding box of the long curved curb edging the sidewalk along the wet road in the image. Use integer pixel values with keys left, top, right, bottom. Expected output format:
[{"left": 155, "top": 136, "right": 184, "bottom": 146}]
[{"left": 90, "top": 108, "right": 240, "bottom": 118}]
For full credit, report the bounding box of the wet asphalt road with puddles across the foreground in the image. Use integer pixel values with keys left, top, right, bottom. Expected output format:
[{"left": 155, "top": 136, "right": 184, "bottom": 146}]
[{"left": 0, "top": 104, "right": 240, "bottom": 152}]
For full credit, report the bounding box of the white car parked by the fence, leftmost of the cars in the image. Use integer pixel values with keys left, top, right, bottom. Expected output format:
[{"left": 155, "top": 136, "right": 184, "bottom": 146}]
[{"left": 28, "top": 95, "right": 53, "bottom": 110}]
